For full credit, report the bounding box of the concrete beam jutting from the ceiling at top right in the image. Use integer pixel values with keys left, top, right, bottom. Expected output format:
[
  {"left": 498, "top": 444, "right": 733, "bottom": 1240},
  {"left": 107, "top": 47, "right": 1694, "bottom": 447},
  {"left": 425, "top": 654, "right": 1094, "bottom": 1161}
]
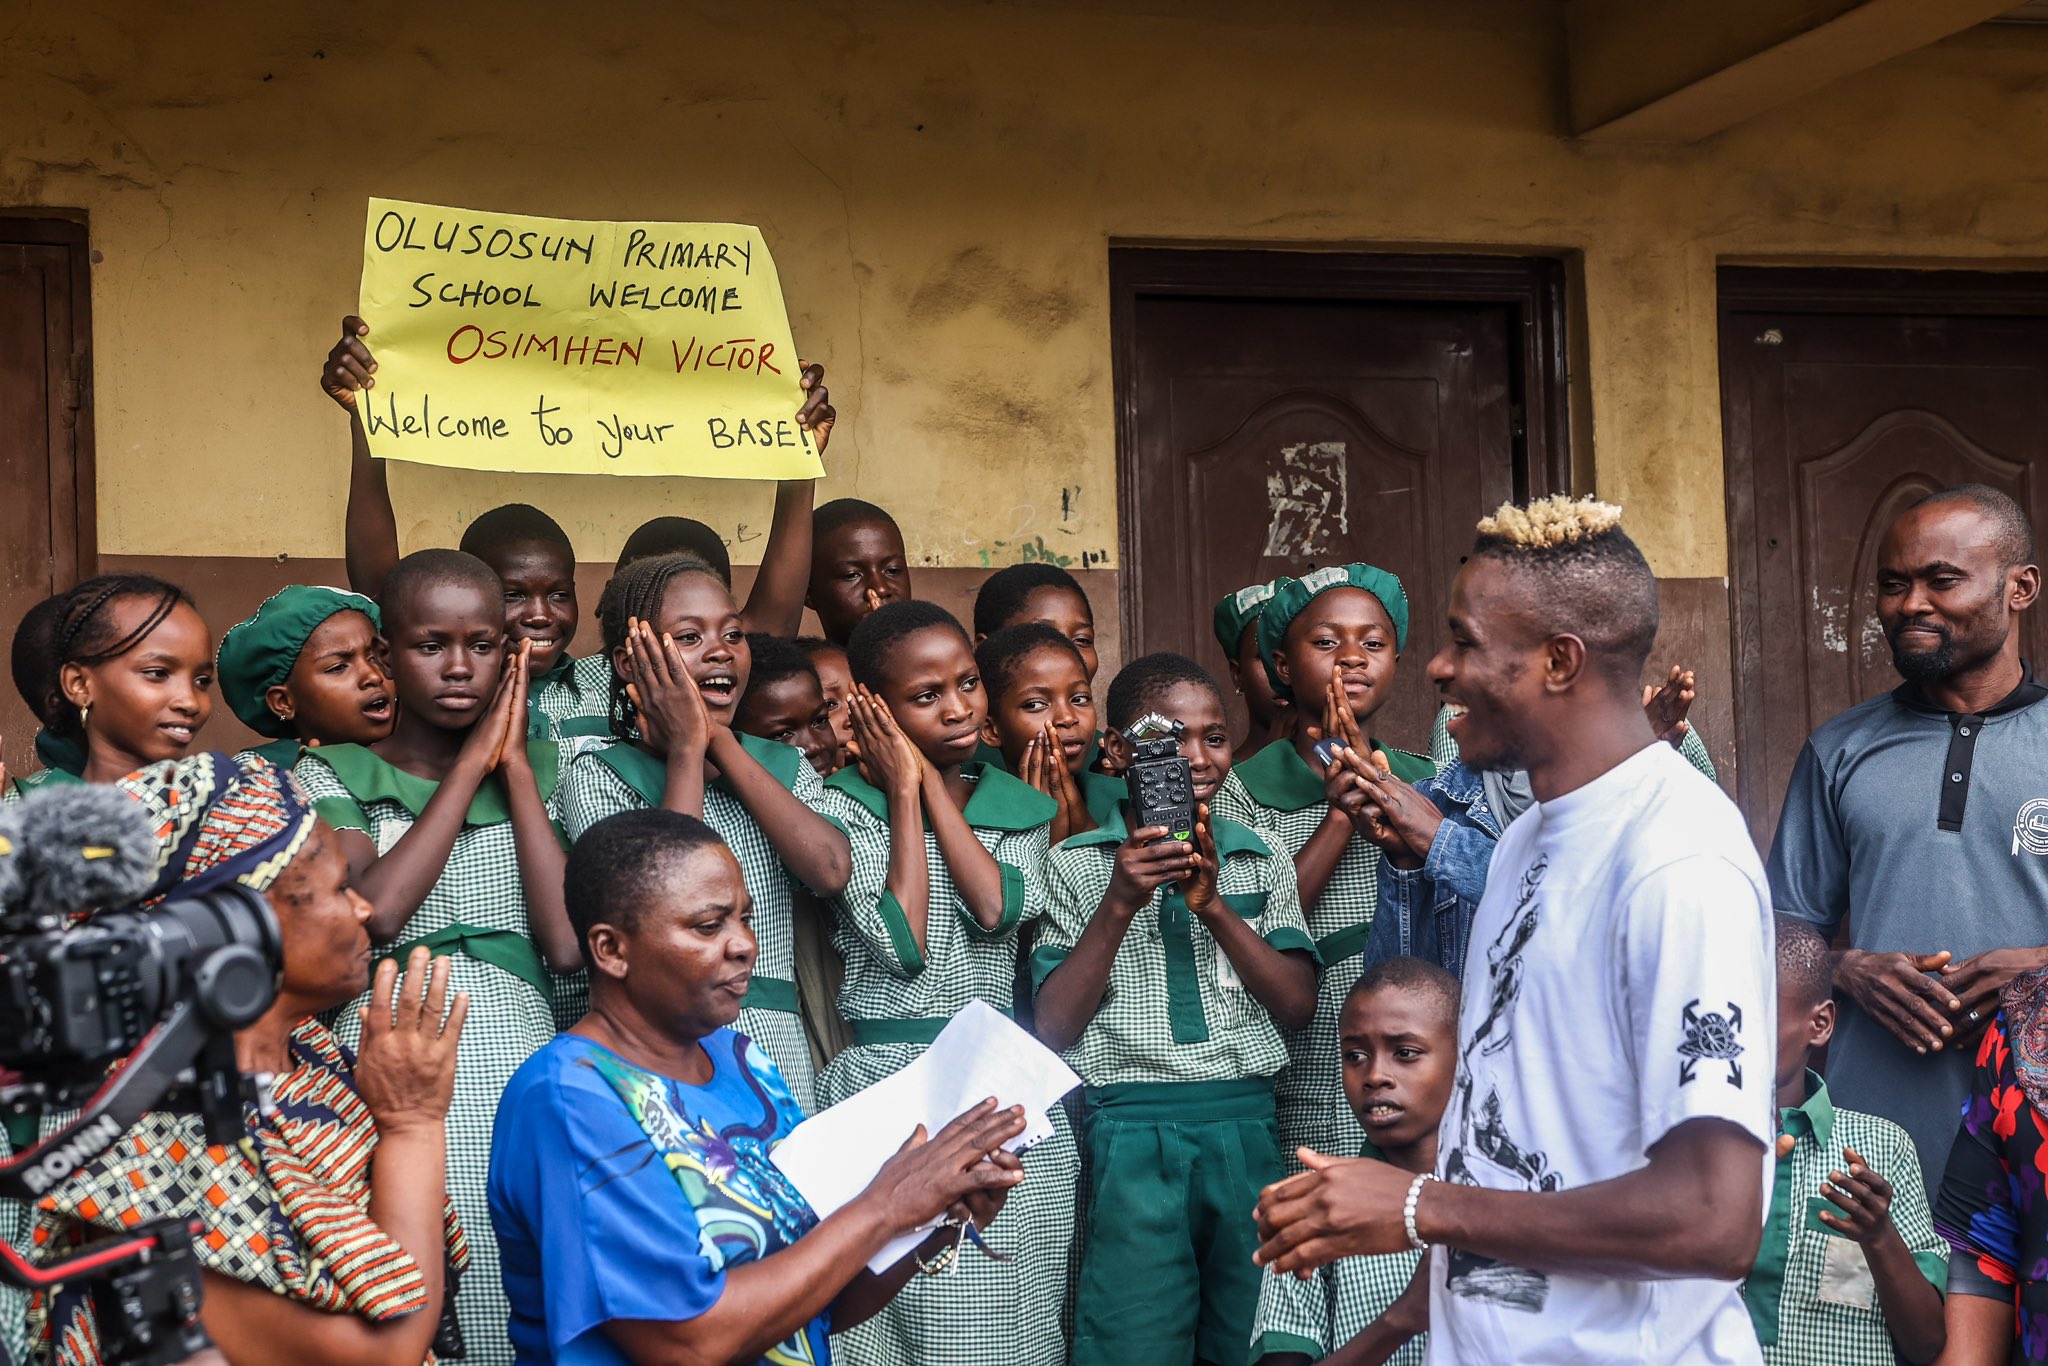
[{"left": 1567, "top": 0, "right": 2013, "bottom": 143}]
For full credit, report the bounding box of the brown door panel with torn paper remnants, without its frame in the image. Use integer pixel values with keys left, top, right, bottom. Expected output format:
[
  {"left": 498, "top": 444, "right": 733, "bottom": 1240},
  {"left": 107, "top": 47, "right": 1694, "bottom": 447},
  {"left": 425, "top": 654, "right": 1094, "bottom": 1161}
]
[{"left": 1137, "top": 299, "right": 1513, "bottom": 748}]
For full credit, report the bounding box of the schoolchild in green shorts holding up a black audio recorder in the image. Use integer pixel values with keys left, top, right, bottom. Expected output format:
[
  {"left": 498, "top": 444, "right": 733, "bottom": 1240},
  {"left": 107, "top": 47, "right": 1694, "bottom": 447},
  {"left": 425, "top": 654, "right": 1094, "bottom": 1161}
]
[{"left": 1032, "top": 651, "right": 1315, "bottom": 1366}]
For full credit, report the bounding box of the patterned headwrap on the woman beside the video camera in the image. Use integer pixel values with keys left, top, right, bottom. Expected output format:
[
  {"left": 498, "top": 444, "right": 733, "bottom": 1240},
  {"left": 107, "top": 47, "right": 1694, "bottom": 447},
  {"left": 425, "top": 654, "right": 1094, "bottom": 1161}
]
[{"left": 115, "top": 752, "right": 313, "bottom": 905}]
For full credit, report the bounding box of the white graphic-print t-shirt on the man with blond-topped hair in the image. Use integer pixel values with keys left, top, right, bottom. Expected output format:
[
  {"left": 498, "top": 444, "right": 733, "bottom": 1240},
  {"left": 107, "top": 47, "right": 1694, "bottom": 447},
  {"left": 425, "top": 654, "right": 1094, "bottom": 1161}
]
[{"left": 1423, "top": 741, "right": 1778, "bottom": 1366}]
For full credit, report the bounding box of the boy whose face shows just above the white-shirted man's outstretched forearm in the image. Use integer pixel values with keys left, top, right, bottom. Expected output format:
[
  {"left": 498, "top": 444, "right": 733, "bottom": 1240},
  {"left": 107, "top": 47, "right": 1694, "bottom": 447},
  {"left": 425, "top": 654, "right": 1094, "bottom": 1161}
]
[{"left": 1251, "top": 958, "right": 1458, "bottom": 1366}]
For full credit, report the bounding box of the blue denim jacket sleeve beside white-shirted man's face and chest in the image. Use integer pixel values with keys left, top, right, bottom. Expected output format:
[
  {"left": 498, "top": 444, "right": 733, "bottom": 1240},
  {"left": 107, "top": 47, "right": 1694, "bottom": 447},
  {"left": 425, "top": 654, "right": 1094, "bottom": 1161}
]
[{"left": 1366, "top": 762, "right": 1499, "bottom": 975}]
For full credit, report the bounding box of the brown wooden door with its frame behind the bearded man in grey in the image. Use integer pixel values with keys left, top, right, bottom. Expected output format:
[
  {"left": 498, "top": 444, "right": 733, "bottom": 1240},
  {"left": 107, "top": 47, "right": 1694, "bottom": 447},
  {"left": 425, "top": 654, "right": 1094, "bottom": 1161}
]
[{"left": 1720, "top": 268, "right": 2048, "bottom": 848}]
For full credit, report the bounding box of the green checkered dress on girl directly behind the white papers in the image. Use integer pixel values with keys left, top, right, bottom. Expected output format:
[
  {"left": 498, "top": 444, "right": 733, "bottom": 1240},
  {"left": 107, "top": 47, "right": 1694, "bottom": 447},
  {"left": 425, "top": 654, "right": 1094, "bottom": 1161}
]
[{"left": 817, "top": 764, "right": 1079, "bottom": 1366}]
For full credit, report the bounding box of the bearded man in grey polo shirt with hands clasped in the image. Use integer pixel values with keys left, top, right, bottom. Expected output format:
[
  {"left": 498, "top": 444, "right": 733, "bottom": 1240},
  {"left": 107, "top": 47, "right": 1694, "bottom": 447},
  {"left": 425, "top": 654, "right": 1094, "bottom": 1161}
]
[{"left": 1769, "top": 483, "right": 2048, "bottom": 1196}]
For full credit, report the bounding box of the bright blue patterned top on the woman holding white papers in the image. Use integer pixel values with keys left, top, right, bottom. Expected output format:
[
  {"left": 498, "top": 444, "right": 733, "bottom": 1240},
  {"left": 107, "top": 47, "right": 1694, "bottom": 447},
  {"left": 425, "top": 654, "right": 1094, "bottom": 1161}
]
[{"left": 489, "top": 1030, "right": 831, "bottom": 1366}]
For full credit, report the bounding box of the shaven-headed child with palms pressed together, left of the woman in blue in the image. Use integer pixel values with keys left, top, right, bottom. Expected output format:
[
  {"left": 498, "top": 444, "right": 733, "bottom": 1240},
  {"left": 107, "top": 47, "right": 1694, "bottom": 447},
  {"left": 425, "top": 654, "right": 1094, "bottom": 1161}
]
[{"left": 293, "top": 551, "right": 592, "bottom": 1366}]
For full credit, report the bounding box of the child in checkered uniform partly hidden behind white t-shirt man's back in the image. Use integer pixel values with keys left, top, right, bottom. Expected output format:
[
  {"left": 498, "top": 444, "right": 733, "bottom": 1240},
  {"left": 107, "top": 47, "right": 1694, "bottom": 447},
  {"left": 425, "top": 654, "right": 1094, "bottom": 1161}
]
[{"left": 1743, "top": 915, "right": 1950, "bottom": 1366}]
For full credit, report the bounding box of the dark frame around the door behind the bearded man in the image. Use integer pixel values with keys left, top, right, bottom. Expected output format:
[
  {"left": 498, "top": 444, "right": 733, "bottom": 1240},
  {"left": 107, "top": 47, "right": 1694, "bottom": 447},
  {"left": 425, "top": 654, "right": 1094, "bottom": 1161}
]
[{"left": 1714, "top": 262, "right": 2048, "bottom": 827}]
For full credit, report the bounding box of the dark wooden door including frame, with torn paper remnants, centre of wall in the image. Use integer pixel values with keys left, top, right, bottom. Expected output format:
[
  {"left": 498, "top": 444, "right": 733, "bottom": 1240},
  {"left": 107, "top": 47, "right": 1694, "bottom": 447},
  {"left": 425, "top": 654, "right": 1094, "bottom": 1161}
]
[{"left": 1112, "top": 250, "right": 1565, "bottom": 750}]
